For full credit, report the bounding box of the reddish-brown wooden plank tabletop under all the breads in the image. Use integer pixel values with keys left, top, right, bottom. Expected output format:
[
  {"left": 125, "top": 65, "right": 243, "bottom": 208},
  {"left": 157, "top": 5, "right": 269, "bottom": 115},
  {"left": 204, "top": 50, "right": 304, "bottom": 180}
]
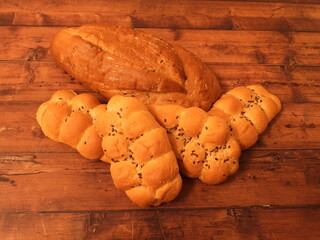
[{"left": 0, "top": 0, "right": 320, "bottom": 240}]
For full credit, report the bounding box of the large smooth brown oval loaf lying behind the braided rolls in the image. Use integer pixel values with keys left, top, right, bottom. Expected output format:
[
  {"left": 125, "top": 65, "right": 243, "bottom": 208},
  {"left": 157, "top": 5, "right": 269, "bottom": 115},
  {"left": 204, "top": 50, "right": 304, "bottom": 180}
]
[{"left": 51, "top": 24, "right": 221, "bottom": 111}]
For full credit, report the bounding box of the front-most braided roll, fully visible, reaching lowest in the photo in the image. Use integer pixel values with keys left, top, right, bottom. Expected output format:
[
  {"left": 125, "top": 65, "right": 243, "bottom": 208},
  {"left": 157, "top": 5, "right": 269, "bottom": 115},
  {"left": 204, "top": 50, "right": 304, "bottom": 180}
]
[{"left": 95, "top": 96, "right": 182, "bottom": 207}]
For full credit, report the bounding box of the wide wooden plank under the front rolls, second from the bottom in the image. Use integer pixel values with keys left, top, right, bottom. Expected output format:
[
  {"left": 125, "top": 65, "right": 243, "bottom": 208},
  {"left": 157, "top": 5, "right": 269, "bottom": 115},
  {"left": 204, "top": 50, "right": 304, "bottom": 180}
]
[{"left": 0, "top": 150, "right": 320, "bottom": 213}]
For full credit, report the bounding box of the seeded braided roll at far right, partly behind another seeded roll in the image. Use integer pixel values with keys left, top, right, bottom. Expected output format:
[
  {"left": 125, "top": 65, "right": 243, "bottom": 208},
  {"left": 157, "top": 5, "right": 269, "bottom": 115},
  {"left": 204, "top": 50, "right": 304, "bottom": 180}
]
[{"left": 208, "top": 85, "right": 281, "bottom": 149}]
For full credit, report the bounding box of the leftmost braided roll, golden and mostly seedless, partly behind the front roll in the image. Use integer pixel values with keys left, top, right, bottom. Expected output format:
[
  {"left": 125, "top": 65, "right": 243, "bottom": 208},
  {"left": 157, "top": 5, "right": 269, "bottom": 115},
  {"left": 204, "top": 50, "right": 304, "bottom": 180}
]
[{"left": 37, "top": 90, "right": 103, "bottom": 159}]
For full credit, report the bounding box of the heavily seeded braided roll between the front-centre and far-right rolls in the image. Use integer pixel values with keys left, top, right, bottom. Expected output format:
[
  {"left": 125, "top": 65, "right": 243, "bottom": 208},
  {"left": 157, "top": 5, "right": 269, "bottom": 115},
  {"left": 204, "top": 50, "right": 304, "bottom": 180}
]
[{"left": 149, "top": 104, "right": 241, "bottom": 184}]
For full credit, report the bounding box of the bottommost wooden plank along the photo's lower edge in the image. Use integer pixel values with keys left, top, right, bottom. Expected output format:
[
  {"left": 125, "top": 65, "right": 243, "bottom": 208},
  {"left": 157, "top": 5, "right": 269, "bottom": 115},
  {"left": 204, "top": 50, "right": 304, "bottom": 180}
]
[{"left": 0, "top": 208, "right": 320, "bottom": 240}]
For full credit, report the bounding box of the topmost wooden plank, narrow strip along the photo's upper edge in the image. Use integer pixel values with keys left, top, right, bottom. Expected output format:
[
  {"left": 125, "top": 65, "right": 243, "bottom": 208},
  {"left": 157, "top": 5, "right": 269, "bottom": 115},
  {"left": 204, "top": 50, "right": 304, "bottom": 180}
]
[{"left": 0, "top": 0, "right": 319, "bottom": 14}]
